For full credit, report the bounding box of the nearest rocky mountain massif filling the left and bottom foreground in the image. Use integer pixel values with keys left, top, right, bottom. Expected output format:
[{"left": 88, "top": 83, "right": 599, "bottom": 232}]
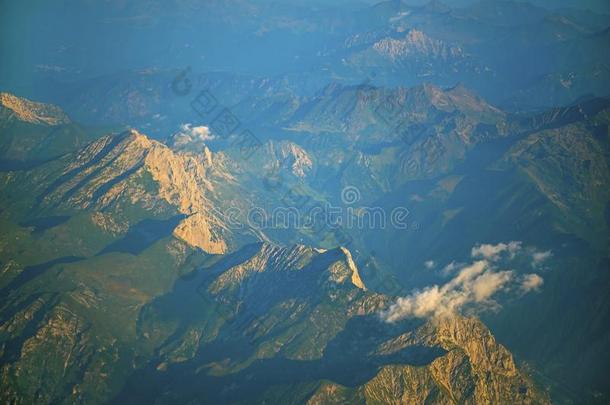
[{"left": 0, "top": 93, "right": 548, "bottom": 403}]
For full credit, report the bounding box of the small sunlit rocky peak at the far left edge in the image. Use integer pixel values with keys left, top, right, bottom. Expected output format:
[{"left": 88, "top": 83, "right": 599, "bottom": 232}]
[{"left": 0, "top": 92, "right": 71, "bottom": 125}]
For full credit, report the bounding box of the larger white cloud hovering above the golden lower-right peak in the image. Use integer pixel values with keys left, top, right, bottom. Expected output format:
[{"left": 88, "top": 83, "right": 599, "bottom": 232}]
[{"left": 380, "top": 241, "right": 548, "bottom": 322}]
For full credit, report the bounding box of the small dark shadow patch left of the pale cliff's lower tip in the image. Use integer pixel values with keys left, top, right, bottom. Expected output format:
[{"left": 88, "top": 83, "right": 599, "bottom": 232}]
[{"left": 96, "top": 214, "right": 187, "bottom": 256}]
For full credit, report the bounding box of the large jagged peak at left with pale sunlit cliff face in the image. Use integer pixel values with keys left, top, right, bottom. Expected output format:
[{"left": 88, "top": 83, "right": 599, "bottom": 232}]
[{"left": 35, "top": 130, "right": 228, "bottom": 253}]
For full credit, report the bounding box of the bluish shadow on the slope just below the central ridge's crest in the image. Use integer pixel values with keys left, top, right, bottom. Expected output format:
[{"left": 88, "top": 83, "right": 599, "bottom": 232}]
[{"left": 138, "top": 244, "right": 352, "bottom": 360}]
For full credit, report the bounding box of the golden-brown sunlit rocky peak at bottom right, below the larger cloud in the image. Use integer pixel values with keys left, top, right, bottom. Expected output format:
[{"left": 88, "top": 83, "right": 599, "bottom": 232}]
[{"left": 308, "top": 316, "right": 549, "bottom": 404}]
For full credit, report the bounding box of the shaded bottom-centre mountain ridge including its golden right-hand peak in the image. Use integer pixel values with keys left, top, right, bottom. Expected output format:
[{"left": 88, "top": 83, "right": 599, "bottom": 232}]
[{"left": 119, "top": 244, "right": 544, "bottom": 403}]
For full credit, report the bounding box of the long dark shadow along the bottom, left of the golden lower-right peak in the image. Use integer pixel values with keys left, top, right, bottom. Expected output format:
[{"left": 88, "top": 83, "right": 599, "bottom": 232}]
[{"left": 113, "top": 316, "right": 446, "bottom": 403}]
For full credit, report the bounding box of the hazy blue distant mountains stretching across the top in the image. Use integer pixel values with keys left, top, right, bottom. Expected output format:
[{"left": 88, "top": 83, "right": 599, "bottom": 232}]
[{"left": 5, "top": 1, "right": 610, "bottom": 115}]
